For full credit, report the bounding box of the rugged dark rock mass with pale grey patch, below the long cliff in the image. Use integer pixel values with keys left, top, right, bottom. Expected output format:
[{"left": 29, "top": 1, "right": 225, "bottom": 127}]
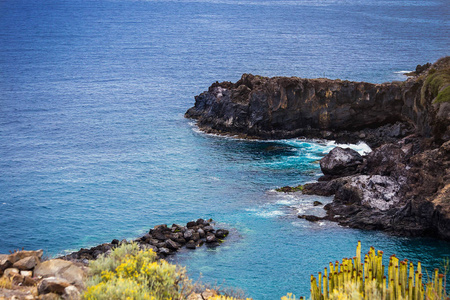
[{"left": 318, "top": 141, "right": 450, "bottom": 239}]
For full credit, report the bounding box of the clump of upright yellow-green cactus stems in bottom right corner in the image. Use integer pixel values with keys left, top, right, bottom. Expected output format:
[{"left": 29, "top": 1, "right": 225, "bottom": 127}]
[{"left": 311, "top": 242, "right": 450, "bottom": 300}]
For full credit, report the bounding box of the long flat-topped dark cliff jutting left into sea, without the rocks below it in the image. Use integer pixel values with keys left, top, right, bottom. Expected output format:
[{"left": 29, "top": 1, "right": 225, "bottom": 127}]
[{"left": 186, "top": 57, "right": 450, "bottom": 146}]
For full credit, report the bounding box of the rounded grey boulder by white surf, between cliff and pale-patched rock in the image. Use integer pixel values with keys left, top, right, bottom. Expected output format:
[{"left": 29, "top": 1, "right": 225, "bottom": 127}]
[{"left": 320, "top": 147, "right": 363, "bottom": 176}]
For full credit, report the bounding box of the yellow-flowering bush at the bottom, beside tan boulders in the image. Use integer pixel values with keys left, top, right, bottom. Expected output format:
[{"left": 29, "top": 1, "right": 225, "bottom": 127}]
[{"left": 83, "top": 244, "right": 192, "bottom": 300}]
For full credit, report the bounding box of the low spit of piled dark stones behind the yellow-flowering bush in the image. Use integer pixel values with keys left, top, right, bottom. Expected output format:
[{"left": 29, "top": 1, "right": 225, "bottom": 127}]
[{"left": 61, "top": 219, "right": 229, "bottom": 263}]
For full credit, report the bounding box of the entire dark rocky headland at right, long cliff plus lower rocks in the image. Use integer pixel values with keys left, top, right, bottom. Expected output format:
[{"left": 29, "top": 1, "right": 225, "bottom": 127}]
[{"left": 186, "top": 57, "right": 450, "bottom": 240}]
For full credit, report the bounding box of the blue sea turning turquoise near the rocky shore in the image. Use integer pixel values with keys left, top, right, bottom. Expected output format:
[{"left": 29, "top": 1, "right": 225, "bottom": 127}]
[{"left": 0, "top": 0, "right": 450, "bottom": 300}]
